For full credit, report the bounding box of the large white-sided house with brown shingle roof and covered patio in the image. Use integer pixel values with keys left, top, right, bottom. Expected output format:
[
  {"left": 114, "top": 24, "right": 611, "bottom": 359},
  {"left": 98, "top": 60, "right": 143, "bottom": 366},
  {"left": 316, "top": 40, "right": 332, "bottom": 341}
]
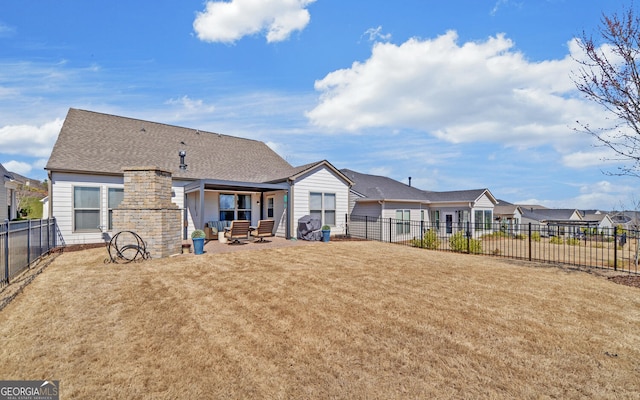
[{"left": 46, "top": 109, "right": 352, "bottom": 244}]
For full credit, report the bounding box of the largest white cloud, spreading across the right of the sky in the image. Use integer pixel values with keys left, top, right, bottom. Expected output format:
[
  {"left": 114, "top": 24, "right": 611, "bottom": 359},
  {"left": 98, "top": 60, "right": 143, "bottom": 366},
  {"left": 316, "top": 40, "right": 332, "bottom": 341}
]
[{"left": 306, "top": 31, "right": 605, "bottom": 153}]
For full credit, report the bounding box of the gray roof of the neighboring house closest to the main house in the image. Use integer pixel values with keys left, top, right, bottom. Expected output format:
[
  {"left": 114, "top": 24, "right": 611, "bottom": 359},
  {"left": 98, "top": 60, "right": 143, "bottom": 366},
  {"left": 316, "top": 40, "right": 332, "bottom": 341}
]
[{"left": 341, "top": 169, "right": 428, "bottom": 202}]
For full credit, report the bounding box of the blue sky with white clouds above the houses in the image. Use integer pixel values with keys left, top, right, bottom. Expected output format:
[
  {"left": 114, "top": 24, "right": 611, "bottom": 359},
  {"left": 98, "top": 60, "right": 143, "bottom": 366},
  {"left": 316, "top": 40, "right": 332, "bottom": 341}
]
[{"left": 0, "top": 0, "right": 640, "bottom": 209}]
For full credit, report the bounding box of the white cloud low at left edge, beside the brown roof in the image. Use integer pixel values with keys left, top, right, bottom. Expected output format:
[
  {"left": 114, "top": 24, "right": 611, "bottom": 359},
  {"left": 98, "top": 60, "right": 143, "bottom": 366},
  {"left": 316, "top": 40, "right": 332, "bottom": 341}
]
[{"left": 0, "top": 118, "right": 62, "bottom": 157}]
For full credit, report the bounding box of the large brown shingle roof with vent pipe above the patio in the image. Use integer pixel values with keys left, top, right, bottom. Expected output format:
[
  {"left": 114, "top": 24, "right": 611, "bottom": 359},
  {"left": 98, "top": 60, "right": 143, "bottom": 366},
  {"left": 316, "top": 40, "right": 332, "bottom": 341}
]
[{"left": 46, "top": 108, "right": 294, "bottom": 182}]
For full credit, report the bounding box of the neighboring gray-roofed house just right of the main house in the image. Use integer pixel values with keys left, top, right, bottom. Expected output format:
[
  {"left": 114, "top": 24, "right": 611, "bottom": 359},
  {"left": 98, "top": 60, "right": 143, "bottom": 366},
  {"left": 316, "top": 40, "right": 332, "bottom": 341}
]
[{"left": 342, "top": 169, "right": 496, "bottom": 240}]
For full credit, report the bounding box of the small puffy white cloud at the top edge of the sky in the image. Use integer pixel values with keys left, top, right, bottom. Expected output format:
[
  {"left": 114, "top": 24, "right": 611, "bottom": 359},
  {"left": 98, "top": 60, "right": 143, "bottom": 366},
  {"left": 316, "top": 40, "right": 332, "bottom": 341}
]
[{"left": 193, "top": 0, "right": 315, "bottom": 43}]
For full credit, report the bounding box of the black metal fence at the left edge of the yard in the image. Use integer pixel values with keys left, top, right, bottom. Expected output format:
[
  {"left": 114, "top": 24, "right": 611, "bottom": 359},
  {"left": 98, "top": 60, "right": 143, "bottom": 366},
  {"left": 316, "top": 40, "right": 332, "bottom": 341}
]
[{"left": 0, "top": 218, "right": 59, "bottom": 288}]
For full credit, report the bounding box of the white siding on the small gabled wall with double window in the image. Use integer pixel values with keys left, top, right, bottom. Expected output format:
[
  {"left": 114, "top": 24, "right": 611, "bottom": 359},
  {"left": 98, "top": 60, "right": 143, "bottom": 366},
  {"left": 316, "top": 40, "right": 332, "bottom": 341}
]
[{"left": 289, "top": 166, "right": 349, "bottom": 237}]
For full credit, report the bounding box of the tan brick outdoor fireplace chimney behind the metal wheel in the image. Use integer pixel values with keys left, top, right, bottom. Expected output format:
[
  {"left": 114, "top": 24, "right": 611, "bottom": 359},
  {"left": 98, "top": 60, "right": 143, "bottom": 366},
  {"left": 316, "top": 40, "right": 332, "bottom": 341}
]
[{"left": 113, "top": 167, "right": 182, "bottom": 258}]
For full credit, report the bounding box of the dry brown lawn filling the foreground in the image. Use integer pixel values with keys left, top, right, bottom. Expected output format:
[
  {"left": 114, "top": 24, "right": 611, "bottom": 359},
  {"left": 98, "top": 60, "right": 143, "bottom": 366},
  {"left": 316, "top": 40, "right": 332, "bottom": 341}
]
[{"left": 0, "top": 242, "right": 640, "bottom": 399}]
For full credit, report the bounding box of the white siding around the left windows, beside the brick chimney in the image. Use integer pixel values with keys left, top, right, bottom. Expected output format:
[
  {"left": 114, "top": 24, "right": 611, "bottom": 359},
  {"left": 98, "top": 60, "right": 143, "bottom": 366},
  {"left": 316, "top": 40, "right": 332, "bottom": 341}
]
[{"left": 49, "top": 173, "right": 184, "bottom": 244}]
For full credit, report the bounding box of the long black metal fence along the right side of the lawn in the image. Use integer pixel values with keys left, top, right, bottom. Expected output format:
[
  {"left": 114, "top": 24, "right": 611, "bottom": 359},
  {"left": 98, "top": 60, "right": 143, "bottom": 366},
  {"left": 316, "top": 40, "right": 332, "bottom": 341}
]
[{"left": 346, "top": 215, "right": 640, "bottom": 274}]
